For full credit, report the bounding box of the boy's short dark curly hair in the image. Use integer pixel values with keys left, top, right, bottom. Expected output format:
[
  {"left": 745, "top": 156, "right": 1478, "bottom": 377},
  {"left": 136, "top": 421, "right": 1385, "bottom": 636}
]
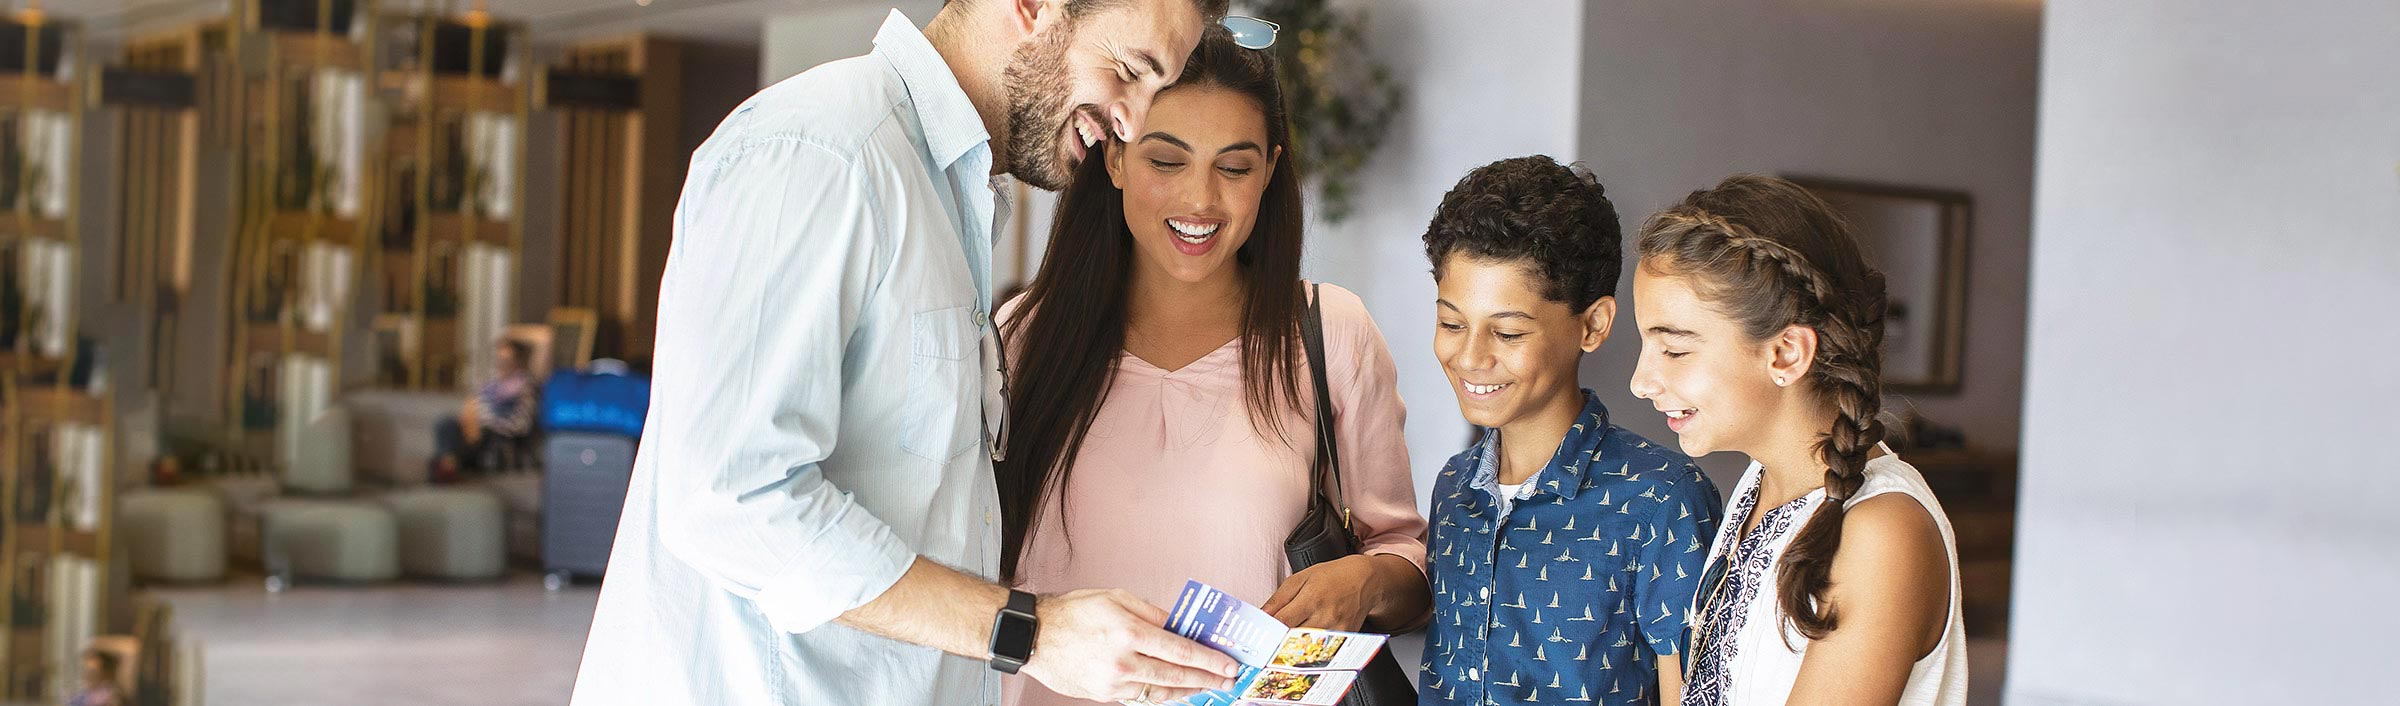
[{"left": 1426, "top": 156, "right": 1625, "bottom": 312}]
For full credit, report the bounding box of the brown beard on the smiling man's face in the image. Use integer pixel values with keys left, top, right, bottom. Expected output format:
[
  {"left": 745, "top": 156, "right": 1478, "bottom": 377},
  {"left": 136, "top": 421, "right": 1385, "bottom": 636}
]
[{"left": 1001, "top": 19, "right": 1099, "bottom": 192}]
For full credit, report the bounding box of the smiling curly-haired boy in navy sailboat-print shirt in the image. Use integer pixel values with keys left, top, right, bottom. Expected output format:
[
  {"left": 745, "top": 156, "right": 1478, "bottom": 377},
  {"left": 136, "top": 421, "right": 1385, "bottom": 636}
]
[{"left": 1421, "top": 156, "right": 1721, "bottom": 706}]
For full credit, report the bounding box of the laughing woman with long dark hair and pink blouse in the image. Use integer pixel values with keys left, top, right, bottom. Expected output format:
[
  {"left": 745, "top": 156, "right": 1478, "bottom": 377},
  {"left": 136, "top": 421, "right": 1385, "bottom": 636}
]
[{"left": 996, "top": 29, "right": 1430, "bottom": 704}]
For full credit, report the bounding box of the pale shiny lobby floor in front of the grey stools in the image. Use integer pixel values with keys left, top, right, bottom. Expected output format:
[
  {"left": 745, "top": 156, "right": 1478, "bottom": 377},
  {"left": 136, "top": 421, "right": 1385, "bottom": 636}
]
[{"left": 156, "top": 574, "right": 600, "bottom": 706}]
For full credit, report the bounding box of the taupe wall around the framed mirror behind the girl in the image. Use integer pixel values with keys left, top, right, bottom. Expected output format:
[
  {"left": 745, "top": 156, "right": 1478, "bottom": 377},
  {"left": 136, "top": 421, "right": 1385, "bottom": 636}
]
[{"left": 1577, "top": 0, "right": 2042, "bottom": 483}]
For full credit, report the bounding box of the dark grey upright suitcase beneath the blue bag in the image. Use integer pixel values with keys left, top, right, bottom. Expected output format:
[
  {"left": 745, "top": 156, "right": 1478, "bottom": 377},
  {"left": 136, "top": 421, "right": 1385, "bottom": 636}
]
[{"left": 542, "top": 432, "right": 636, "bottom": 588}]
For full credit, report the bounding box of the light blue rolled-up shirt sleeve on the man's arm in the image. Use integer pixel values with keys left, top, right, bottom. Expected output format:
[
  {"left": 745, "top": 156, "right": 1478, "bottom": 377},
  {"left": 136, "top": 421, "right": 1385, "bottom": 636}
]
[{"left": 643, "top": 139, "right": 917, "bottom": 634}]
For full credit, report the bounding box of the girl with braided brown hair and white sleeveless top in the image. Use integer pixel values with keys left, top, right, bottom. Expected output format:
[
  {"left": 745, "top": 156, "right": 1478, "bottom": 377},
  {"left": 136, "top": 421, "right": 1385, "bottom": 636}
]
[{"left": 1632, "top": 175, "right": 1966, "bottom": 706}]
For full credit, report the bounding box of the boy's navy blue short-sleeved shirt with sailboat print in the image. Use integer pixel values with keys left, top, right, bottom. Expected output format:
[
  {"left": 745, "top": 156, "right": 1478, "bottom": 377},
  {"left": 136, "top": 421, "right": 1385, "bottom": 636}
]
[{"left": 1421, "top": 391, "right": 1723, "bottom": 706}]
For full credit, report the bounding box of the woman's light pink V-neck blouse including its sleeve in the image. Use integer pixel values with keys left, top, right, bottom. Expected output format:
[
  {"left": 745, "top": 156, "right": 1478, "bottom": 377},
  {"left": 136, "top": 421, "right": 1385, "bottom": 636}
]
[{"left": 1003, "top": 286, "right": 1426, "bottom": 706}]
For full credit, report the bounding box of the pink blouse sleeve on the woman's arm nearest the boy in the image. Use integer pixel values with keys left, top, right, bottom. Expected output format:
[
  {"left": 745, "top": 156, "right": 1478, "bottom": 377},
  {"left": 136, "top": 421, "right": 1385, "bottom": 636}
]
[{"left": 1320, "top": 288, "right": 1426, "bottom": 572}]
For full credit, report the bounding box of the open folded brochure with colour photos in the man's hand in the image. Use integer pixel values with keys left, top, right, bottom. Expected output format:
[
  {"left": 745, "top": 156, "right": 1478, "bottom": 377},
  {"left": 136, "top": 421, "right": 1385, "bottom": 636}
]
[{"left": 1137, "top": 581, "right": 1390, "bottom": 706}]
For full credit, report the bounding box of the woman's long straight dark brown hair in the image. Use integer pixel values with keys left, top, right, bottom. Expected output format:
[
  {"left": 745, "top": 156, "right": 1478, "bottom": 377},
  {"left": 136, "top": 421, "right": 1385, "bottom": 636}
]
[{"left": 994, "top": 26, "right": 1306, "bottom": 581}]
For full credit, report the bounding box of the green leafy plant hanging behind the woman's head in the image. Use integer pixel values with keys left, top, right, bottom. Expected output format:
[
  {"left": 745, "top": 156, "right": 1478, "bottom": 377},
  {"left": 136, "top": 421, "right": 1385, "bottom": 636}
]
[{"left": 1248, "top": 0, "right": 1404, "bottom": 223}]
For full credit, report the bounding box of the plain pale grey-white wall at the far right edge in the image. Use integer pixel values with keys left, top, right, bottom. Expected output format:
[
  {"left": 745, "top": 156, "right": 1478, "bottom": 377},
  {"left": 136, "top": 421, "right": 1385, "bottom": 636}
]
[{"left": 2009, "top": 0, "right": 2400, "bottom": 706}]
